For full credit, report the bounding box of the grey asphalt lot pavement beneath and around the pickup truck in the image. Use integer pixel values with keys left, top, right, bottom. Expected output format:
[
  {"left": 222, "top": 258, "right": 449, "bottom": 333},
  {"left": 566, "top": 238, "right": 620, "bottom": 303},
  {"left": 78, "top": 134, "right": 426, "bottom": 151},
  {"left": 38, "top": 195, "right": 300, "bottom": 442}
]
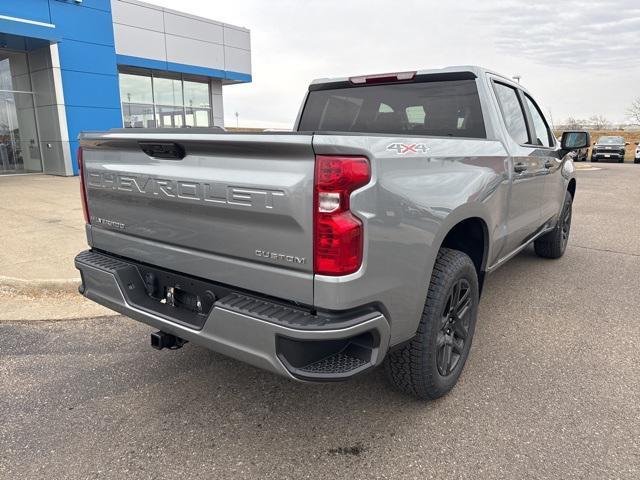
[{"left": 0, "top": 165, "right": 640, "bottom": 479}]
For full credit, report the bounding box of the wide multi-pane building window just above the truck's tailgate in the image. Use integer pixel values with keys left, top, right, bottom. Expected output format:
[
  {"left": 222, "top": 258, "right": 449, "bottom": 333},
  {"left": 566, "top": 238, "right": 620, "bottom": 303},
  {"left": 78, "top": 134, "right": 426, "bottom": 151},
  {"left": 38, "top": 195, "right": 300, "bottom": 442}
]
[{"left": 120, "top": 73, "right": 213, "bottom": 128}]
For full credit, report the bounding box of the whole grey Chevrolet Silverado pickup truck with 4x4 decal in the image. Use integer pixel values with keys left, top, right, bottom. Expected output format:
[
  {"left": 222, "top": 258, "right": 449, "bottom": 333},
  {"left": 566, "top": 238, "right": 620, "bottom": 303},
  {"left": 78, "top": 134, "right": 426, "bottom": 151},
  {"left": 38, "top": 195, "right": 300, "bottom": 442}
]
[{"left": 75, "top": 67, "right": 590, "bottom": 399}]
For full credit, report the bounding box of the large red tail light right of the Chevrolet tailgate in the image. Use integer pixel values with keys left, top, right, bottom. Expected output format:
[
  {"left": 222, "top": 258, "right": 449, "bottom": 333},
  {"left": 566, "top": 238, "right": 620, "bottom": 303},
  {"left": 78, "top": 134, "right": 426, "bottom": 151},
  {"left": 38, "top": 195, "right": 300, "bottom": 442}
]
[{"left": 314, "top": 155, "right": 371, "bottom": 275}]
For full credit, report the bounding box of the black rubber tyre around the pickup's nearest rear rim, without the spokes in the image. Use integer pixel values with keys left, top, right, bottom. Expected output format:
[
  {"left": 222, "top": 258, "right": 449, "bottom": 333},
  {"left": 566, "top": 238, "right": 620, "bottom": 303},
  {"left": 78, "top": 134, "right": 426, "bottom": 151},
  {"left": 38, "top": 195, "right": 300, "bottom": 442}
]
[{"left": 385, "top": 248, "right": 479, "bottom": 400}]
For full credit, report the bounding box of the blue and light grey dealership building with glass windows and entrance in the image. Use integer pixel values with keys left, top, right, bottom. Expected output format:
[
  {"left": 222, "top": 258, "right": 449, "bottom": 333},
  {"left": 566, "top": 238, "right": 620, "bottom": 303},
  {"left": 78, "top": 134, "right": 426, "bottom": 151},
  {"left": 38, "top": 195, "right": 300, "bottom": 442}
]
[{"left": 0, "top": 0, "right": 251, "bottom": 175}]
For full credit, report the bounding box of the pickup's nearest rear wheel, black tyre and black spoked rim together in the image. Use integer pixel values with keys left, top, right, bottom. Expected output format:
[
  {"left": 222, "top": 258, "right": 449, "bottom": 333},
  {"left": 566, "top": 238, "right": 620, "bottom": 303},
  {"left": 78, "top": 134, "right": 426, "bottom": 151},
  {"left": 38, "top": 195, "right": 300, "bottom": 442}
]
[{"left": 385, "top": 248, "right": 479, "bottom": 400}]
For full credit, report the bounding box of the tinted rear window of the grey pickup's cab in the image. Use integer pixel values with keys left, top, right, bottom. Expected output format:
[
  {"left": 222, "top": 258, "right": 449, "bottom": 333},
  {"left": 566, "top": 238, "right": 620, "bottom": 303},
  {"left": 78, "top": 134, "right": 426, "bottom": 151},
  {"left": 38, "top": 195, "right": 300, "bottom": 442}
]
[{"left": 298, "top": 80, "right": 486, "bottom": 138}]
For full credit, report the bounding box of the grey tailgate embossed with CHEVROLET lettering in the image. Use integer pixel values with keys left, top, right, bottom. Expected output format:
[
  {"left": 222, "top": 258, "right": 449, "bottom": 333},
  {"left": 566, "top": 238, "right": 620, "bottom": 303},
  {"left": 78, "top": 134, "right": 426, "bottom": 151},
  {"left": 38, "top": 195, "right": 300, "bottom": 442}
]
[{"left": 81, "top": 131, "right": 314, "bottom": 304}]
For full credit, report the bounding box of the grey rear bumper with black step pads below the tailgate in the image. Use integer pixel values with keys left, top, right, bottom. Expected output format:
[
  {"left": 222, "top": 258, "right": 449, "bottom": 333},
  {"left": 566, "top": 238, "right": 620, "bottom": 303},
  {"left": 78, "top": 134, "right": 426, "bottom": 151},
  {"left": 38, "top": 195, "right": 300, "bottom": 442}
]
[{"left": 75, "top": 251, "right": 390, "bottom": 381}]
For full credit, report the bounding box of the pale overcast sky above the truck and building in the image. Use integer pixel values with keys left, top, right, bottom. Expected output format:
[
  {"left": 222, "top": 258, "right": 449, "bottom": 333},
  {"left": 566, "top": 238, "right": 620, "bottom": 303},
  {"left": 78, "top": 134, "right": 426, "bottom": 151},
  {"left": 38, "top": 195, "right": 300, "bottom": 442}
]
[{"left": 148, "top": 0, "right": 640, "bottom": 128}]
